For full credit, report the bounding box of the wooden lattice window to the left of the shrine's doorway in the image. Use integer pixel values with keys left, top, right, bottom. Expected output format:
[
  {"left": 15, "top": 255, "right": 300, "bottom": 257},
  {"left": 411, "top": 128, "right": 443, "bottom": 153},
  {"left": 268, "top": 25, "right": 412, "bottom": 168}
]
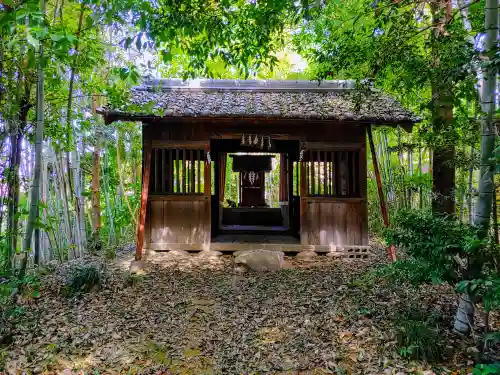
[{"left": 150, "top": 147, "right": 205, "bottom": 194}]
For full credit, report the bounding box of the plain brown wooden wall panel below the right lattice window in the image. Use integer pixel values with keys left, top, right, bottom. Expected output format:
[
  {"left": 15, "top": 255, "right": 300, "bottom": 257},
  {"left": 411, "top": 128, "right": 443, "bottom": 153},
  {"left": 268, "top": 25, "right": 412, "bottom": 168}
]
[{"left": 301, "top": 197, "right": 368, "bottom": 246}]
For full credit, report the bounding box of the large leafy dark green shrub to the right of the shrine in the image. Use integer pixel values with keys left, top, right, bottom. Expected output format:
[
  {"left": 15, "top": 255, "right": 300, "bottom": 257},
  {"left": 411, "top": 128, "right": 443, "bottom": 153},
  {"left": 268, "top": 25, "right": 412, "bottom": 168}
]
[{"left": 377, "top": 211, "right": 500, "bottom": 362}]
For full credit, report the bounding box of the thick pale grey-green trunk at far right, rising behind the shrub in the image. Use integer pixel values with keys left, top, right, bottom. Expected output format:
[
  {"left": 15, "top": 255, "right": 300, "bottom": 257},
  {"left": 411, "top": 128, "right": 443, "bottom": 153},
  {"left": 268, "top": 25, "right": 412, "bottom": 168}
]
[{"left": 453, "top": 0, "right": 499, "bottom": 335}]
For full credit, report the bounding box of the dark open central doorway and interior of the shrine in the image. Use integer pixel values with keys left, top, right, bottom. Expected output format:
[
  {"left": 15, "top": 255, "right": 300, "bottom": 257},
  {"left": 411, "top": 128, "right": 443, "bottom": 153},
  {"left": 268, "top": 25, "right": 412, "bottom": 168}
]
[{"left": 210, "top": 139, "right": 300, "bottom": 238}]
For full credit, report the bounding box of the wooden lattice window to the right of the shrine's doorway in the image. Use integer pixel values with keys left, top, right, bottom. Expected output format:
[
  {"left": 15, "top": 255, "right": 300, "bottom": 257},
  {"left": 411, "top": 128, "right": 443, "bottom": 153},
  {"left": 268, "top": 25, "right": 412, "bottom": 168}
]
[{"left": 294, "top": 150, "right": 361, "bottom": 198}]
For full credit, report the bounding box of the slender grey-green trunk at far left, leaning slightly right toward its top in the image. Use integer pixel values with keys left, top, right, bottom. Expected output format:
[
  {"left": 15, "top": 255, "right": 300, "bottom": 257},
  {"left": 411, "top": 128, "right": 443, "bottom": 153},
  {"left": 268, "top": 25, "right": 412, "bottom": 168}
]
[{"left": 23, "top": 0, "right": 45, "bottom": 265}]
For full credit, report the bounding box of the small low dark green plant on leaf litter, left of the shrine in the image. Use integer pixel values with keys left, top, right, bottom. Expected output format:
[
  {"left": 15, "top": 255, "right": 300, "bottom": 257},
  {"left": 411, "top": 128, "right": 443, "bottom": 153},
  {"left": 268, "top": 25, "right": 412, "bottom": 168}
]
[{"left": 63, "top": 265, "right": 103, "bottom": 297}]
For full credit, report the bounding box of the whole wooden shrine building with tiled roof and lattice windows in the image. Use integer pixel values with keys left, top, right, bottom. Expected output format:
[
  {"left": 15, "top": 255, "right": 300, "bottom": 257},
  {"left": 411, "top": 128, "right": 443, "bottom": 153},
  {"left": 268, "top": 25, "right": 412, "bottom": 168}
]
[{"left": 99, "top": 80, "right": 417, "bottom": 259}]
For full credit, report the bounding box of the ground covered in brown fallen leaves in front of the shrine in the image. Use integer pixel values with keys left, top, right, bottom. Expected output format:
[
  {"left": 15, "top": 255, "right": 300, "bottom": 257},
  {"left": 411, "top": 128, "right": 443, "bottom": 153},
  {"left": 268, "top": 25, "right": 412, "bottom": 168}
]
[{"left": 0, "top": 249, "right": 490, "bottom": 375}]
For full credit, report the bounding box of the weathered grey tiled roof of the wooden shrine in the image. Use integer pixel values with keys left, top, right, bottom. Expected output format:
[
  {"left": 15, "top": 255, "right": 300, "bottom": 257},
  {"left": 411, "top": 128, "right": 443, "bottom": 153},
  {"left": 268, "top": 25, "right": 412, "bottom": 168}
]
[{"left": 100, "top": 80, "right": 418, "bottom": 124}]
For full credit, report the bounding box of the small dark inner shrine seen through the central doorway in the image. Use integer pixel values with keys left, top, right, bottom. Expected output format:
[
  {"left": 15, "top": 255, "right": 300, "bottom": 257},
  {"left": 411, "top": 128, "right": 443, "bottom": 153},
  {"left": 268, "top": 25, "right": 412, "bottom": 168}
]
[{"left": 230, "top": 154, "right": 273, "bottom": 207}]
